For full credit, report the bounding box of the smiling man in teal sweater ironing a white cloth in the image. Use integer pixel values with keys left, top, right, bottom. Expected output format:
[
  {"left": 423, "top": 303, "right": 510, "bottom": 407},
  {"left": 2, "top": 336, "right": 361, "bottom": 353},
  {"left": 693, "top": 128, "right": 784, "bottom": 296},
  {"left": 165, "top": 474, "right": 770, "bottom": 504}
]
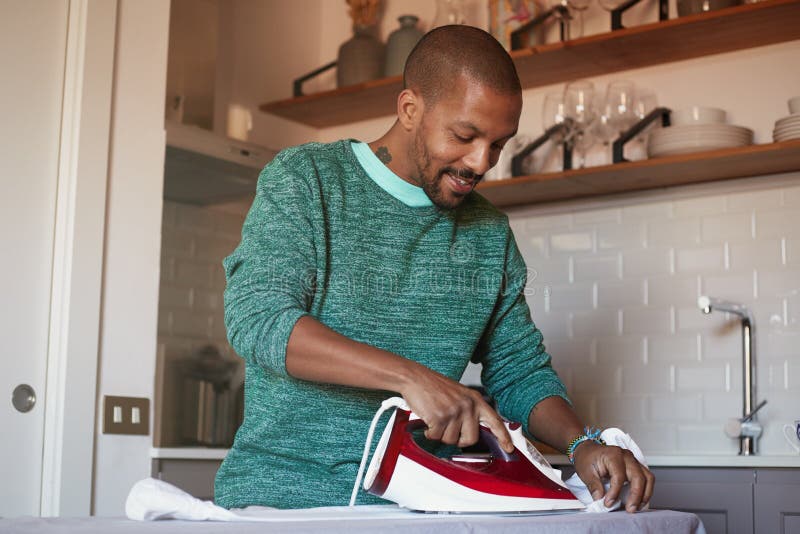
[{"left": 216, "top": 26, "right": 653, "bottom": 511}]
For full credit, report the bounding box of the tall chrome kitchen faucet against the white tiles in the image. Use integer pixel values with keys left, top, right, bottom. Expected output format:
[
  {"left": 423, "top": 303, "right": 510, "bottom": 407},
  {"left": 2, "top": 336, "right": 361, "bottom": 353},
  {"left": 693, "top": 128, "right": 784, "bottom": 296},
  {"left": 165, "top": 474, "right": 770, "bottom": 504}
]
[{"left": 697, "top": 295, "right": 767, "bottom": 456}]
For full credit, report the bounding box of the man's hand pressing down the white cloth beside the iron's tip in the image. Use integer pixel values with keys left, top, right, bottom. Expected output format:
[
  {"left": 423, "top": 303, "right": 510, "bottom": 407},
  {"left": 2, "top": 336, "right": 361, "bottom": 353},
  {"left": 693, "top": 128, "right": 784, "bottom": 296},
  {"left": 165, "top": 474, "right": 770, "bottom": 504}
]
[{"left": 575, "top": 441, "right": 655, "bottom": 513}]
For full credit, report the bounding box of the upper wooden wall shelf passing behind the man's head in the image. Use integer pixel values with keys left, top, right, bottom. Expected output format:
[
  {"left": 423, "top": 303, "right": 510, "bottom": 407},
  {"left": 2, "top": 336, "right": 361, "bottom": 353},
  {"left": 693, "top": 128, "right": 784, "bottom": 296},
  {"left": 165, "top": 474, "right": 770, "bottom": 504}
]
[{"left": 260, "top": 0, "right": 800, "bottom": 128}]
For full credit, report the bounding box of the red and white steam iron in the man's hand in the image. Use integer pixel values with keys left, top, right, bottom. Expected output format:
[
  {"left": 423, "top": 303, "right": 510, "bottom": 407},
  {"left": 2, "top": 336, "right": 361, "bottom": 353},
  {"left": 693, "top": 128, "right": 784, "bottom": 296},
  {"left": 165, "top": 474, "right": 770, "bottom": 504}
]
[{"left": 350, "top": 397, "right": 584, "bottom": 513}]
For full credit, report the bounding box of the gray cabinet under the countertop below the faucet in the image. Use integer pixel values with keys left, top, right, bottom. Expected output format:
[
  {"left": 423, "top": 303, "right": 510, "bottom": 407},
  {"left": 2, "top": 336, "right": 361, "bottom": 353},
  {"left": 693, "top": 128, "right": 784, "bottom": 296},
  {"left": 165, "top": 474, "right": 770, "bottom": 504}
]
[{"left": 651, "top": 467, "right": 800, "bottom": 534}]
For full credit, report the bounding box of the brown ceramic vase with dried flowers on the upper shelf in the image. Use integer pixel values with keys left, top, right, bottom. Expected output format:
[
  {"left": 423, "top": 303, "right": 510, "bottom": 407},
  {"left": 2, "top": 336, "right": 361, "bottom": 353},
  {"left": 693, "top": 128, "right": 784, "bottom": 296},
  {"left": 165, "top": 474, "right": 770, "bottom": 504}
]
[{"left": 336, "top": 24, "right": 384, "bottom": 87}]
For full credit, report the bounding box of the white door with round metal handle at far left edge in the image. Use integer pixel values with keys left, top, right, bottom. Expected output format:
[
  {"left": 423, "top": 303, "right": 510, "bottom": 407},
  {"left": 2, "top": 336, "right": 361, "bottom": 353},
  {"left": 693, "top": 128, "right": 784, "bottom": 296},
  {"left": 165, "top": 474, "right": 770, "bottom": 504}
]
[{"left": 0, "top": 0, "right": 68, "bottom": 517}]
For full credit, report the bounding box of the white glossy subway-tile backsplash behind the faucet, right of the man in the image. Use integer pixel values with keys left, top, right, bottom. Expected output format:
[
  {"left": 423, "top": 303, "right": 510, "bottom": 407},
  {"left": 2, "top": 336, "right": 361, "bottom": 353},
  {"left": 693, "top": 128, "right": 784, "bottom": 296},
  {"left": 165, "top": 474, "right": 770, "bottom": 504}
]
[{"left": 510, "top": 175, "right": 800, "bottom": 454}]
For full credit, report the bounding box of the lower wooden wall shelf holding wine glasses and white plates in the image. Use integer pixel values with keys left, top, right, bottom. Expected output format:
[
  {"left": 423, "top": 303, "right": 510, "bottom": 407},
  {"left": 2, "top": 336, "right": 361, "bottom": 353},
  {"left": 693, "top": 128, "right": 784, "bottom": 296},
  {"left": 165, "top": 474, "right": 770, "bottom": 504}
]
[{"left": 477, "top": 140, "right": 800, "bottom": 207}]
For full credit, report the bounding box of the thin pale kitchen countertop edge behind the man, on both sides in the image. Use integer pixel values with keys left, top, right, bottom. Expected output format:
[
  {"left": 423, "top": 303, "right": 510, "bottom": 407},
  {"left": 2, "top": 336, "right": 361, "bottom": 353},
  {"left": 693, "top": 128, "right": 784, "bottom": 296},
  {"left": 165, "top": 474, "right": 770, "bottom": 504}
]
[{"left": 150, "top": 447, "right": 800, "bottom": 468}]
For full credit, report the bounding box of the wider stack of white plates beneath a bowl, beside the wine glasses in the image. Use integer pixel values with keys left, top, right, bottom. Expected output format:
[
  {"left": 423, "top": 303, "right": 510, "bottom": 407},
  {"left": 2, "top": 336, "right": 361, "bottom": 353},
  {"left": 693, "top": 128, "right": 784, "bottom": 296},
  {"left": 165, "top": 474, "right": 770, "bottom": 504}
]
[{"left": 647, "top": 123, "right": 753, "bottom": 158}]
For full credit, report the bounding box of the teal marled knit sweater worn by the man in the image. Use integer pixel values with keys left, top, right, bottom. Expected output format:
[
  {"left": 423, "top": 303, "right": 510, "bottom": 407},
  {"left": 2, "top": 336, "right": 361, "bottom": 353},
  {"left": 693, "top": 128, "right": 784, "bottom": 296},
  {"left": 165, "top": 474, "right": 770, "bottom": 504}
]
[{"left": 215, "top": 140, "right": 566, "bottom": 508}]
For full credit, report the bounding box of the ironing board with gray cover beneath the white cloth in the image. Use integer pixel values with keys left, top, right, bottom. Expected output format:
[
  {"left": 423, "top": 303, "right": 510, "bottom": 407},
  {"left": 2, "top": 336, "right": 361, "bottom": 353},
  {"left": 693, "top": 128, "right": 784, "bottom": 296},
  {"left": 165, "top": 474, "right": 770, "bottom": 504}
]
[{"left": 0, "top": 510, "right": 705, "bottom": 534}]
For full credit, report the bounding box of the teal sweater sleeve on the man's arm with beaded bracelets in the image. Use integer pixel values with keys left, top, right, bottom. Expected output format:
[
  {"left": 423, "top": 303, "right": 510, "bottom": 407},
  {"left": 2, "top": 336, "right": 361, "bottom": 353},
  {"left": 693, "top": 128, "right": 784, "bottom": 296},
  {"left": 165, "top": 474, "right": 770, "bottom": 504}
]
[{"left": 476, "top": 229, "right": 569, "bottom": 434}]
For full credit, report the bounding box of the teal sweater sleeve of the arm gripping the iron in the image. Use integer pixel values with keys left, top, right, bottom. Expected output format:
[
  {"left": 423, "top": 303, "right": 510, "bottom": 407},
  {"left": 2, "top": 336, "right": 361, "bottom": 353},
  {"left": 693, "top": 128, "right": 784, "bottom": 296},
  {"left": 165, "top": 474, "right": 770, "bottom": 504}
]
[{"left": 223, "top": 151, "right": 316, "bottom": 375}]
